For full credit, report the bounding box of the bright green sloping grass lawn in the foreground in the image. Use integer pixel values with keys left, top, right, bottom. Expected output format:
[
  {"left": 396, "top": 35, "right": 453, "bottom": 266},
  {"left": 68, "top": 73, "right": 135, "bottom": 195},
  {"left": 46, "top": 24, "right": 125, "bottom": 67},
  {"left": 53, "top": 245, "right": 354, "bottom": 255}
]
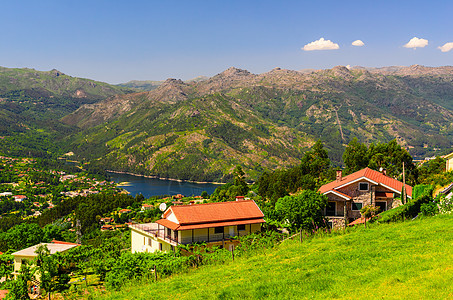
[{"left": 95, "top": 215, "right": 453, "bottom": 300}]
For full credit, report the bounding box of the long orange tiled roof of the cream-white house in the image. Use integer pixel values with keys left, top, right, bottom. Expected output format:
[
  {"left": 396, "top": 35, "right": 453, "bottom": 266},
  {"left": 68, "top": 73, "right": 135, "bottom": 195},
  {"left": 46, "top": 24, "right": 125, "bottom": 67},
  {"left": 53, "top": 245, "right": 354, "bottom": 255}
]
[{"left": 156, "top": 200, "right": 265, "bottom": 230}]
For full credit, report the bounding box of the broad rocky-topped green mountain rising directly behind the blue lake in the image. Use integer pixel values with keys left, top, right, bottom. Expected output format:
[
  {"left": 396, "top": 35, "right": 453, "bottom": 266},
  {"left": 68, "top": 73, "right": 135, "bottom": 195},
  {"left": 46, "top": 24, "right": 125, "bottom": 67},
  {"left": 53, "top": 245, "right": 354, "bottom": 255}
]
[{"left": 63, "top": 66, "right": 453, "bottom": 180}]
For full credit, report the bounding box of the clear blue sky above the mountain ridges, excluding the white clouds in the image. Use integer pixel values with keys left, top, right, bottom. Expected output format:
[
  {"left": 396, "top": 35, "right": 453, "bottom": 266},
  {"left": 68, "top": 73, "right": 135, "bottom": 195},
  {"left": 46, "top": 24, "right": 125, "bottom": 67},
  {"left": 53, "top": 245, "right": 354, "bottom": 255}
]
[{"left": 0, "top": 0, "right": 453, "bottom": 83}]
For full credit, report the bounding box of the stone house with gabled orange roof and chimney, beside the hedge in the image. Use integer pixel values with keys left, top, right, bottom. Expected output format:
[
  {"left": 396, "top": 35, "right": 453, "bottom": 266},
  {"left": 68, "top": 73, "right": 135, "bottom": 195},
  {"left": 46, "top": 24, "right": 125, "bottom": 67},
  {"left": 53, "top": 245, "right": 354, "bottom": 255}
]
[{"left": 319, "top": 168, "right": 412, "bottom": 228}]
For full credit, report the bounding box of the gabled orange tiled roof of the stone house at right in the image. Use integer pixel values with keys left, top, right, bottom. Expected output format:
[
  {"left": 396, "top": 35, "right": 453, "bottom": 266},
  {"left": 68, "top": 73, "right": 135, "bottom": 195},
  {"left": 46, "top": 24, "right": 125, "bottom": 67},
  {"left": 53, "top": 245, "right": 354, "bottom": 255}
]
[{"left": 319, "top": 168, "right": 412, "bottom": 197}]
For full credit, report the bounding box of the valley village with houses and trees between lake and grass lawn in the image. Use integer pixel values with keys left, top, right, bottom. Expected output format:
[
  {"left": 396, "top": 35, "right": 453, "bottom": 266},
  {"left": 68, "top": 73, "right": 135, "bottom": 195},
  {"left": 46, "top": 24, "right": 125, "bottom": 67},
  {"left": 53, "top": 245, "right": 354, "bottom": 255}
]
[{"left": 0, "top": 141, "right": 453, "bottom": 298}]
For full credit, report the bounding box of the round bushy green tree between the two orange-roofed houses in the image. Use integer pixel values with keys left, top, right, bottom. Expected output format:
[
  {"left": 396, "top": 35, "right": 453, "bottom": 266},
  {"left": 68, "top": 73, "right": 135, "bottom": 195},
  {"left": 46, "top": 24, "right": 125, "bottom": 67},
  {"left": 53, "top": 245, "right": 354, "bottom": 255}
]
[{"left": 275, "top": 190, "right": 327, "bottom": 229}]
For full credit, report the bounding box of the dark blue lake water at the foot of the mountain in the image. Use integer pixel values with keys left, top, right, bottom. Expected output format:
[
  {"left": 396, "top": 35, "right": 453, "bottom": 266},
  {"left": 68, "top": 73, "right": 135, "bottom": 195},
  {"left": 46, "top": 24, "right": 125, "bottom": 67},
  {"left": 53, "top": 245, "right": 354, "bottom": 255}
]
[{"left": 109, "top": 172, "right": 220, "bottom": 198}]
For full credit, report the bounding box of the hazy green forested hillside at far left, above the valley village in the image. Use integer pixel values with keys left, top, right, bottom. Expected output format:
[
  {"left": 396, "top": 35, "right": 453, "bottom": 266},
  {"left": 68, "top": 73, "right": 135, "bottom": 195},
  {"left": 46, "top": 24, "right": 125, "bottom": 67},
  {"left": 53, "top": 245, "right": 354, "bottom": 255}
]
[{"left": 0, "top": 67, "right": 132, "bottom": 156}]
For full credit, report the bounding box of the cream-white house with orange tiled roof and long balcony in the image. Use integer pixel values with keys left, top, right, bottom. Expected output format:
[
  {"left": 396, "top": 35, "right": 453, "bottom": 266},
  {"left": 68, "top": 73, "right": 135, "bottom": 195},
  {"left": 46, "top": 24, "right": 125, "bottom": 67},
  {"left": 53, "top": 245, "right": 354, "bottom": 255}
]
[{"left": 129, "top": 200, "right": 265, "bottom": 253}]
